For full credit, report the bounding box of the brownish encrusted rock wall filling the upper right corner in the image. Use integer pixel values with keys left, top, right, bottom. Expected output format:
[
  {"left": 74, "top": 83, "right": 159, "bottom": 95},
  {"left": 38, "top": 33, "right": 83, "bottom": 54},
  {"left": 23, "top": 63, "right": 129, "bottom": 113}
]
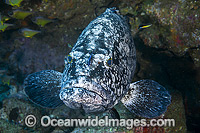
[{"left": 119, "top": 0, "right": 200, "bottom": 67}]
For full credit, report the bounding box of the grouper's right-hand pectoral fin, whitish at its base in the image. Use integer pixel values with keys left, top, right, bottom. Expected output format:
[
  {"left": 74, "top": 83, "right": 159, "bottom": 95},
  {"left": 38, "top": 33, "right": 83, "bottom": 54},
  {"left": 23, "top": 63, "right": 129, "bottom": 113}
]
[{"left": 121, "top": 80, "right": 171, "bottom": 118}]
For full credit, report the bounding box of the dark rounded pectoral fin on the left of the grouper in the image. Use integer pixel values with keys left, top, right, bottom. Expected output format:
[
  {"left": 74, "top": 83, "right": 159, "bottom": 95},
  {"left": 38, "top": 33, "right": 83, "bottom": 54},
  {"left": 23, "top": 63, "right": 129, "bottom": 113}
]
[{"left": 24, "top": 70, "right": 63, "bottom": 108}]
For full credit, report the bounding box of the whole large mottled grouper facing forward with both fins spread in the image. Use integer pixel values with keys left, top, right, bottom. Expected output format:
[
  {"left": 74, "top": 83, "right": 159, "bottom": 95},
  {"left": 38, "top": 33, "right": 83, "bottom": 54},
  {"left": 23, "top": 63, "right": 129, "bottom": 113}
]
[{"left": 24, "top": 8, "right": 171, "bottom": 118}]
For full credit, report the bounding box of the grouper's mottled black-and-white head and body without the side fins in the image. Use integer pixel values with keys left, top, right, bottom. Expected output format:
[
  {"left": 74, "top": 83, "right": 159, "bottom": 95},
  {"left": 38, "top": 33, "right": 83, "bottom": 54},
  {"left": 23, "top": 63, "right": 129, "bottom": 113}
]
[{"left": 60, "top": 9, "right": 136, "bottom": 112}]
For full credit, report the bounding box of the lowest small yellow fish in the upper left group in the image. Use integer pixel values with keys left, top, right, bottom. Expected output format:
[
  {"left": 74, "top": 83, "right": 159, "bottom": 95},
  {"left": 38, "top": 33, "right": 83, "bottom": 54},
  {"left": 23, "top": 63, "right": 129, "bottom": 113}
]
[{"left": 19, "top": 28, "right": 41, "bottom": 38}]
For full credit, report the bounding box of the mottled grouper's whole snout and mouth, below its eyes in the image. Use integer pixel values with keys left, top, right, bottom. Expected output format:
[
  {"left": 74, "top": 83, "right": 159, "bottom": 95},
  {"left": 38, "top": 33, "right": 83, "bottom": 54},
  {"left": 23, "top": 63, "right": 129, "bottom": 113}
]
[{"left": 60, "top": 76, "right": 111, "bottom": 113}]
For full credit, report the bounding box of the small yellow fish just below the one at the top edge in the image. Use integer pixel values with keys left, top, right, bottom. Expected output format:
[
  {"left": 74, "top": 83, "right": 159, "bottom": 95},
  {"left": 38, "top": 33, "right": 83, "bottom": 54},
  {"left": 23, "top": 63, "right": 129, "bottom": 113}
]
[{"left": 8, "top": 9, "right": 33, "bottom": 20}]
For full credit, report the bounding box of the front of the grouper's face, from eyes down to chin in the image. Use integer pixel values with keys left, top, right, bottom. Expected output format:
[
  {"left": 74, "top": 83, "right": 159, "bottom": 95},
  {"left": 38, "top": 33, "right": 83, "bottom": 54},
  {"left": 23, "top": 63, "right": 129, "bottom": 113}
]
[{"left": 60, "top": 48, "right": 114, "bottom": 113}]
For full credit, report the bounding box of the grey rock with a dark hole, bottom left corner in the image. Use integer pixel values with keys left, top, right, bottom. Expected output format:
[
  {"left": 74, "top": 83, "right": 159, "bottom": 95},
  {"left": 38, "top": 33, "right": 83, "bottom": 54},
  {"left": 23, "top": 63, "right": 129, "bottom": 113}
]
[{"left": 0, "top": 97, "right": 42, "bottom": 132}]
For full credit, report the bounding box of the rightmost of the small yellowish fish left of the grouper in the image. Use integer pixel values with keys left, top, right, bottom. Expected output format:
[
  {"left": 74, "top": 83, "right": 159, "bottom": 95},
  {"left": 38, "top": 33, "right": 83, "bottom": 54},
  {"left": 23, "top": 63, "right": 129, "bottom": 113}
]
[{"left": 32, "top": 17, "right": 55, "bottom": 27}]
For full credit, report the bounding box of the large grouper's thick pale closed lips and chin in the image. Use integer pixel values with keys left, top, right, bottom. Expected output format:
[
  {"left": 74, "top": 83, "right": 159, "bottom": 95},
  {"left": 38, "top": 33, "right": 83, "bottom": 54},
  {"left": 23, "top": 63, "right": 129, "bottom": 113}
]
[{"left": 60, "top": 88, "right": 105, "bottom": 113}]
